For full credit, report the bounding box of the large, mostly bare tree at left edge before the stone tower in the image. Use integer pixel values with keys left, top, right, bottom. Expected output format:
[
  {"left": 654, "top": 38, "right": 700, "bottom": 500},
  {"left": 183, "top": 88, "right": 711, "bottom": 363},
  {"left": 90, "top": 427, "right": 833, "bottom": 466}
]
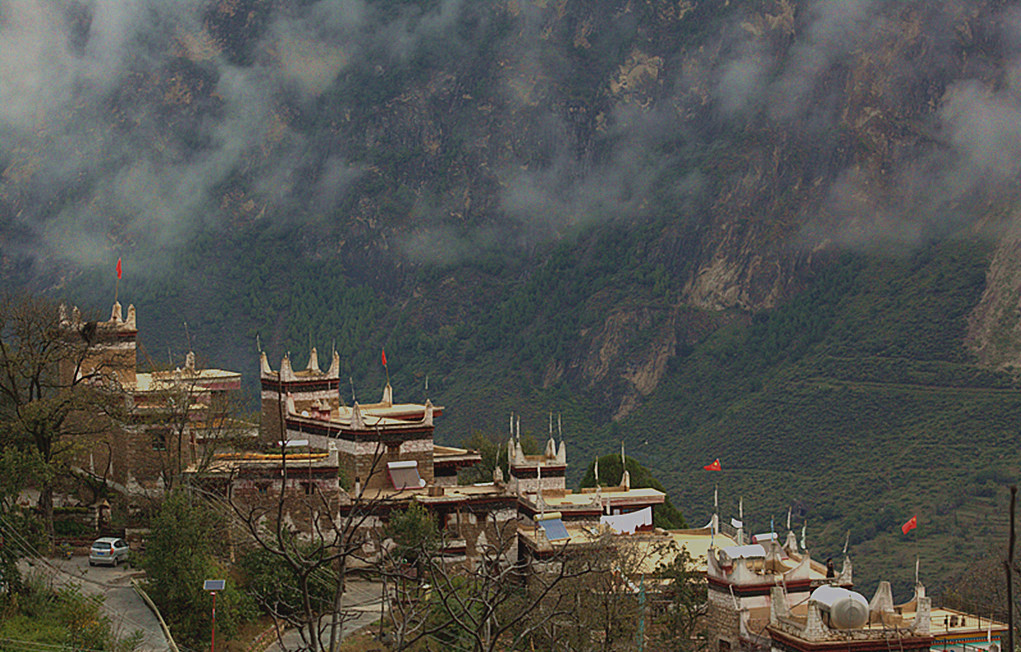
[{"left": 0, "top": 294, "right": 124, "bottom": 541}]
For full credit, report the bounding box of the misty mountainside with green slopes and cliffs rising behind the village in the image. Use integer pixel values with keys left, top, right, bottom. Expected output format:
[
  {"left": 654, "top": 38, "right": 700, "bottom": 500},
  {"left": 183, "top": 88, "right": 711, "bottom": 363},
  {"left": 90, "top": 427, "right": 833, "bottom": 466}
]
[{"left": 0, "top": 0, "right": 1021, "bottom": 604}]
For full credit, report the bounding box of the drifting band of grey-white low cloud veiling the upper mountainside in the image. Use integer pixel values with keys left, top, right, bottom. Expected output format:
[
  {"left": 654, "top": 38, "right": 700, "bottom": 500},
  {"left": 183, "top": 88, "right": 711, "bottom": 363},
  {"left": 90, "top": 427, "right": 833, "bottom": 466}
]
[{"left": 0, "top": 0, "right": 1021, "bottom": 281}]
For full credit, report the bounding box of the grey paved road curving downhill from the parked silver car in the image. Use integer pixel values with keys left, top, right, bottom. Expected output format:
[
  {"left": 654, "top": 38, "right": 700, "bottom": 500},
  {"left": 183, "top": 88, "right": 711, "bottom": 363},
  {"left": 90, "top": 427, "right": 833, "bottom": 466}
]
[{"left": 20, "top": 556, "right": 169, "bottom": 652}]
